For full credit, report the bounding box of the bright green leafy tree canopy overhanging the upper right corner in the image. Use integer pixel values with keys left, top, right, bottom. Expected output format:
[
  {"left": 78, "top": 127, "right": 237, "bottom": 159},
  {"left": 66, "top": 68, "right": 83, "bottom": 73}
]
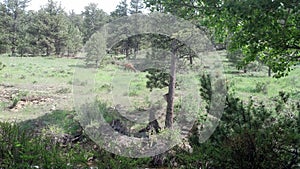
[{"left": 146, "top": 0, "right": 300, "bottom": 77}]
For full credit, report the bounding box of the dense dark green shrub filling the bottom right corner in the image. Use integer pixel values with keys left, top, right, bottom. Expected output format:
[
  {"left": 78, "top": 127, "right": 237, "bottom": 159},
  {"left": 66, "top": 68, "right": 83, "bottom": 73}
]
[{"left": 189, "top": 74, "right": 300, "bottom": 169}]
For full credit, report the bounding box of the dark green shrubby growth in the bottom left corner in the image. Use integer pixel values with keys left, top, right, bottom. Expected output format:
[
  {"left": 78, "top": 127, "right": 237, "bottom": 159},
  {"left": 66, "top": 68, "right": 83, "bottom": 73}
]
[{"left": 0, "top": 122, "right": 84, "bottom": 169}]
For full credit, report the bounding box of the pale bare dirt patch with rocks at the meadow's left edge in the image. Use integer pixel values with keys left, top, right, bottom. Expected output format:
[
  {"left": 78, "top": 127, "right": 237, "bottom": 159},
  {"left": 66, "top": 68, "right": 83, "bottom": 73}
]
[{"left": 0, "top": 84, "right": 72, "bottom": 120}]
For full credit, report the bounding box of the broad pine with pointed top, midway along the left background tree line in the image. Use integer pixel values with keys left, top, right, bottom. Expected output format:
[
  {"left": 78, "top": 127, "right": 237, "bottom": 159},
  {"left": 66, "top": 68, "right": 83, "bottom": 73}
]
[{"left": 29, "top": 0, "right": 68, "bottom": 56}]
